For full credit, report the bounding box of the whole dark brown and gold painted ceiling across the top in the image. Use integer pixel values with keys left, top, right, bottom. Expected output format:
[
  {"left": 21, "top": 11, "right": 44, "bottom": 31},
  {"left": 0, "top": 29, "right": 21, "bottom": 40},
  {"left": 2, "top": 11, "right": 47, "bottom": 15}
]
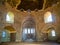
[{"left": 0, "top": 0, "right": 60, "bottom": 10}]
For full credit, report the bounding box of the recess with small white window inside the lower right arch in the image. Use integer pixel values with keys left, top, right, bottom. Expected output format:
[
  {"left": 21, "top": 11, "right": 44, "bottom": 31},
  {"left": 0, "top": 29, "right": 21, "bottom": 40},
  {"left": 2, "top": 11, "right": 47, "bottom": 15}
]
[{"left": 47, "top": 27, "right": 57, "bottom": 41}]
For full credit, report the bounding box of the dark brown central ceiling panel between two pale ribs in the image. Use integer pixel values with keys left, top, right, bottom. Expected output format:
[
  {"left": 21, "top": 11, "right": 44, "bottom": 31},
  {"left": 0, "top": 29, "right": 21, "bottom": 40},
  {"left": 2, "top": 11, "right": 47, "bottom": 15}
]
[{"left": 17, "top": 0, "right": 44, "bottom": 10}]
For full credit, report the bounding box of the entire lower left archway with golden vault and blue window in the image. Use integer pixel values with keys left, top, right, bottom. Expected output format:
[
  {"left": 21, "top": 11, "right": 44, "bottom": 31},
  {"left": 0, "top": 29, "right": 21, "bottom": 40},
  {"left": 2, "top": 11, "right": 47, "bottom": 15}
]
[{"left": 1, "top": 26, "right": 16, "bottom": 42}]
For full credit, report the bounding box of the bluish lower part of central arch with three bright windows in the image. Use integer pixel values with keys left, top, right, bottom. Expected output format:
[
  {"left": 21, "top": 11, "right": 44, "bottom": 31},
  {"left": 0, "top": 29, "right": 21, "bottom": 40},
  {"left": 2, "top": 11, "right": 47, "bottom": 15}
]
[{"left": 23, "top": 28, "right": 36, "bottom": 41}]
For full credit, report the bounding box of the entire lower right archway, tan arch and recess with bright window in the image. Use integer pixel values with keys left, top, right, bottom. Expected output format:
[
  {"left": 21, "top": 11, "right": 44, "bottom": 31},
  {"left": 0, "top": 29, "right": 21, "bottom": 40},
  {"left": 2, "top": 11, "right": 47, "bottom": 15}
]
[{"left": 42, "top": 25, "right": 58, "bottom": 41}]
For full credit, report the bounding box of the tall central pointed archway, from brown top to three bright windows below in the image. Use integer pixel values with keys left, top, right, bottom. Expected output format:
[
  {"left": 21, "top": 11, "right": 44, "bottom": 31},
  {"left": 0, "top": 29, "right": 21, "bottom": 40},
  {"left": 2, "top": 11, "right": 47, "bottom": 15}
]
[{"left": 22, "top": 16, "right": 36, "bottom": 41}]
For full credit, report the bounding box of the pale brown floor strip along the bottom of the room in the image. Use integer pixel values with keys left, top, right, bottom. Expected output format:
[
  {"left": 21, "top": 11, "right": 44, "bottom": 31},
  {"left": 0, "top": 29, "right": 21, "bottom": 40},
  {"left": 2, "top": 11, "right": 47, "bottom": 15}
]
[{"left": 0, "top": 42, "right": 60, "bottom": 45}]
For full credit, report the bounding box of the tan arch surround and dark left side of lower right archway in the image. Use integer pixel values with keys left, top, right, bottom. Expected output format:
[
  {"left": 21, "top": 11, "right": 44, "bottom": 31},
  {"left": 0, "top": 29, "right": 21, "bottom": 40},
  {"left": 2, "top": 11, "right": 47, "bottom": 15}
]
[{"left": 41, "top": 25, "right": 55, "bottom": 41}]
